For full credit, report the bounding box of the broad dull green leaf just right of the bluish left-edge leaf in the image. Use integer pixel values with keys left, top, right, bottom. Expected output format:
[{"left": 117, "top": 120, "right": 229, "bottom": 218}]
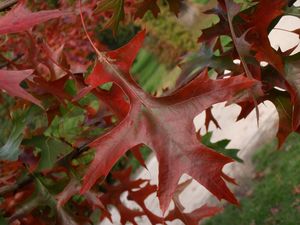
[{"left": 23, "top": 136, "right": 73, "bottom": 170}]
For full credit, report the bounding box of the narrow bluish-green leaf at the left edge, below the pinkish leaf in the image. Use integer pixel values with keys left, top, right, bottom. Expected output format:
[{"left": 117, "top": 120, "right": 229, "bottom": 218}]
[{"left": 0, "top": 106, "right": 41, "bottom": 161}]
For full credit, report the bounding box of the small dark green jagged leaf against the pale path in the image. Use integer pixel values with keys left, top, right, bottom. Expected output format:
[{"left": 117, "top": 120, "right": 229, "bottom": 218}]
[{"left": 201, "top": 132, "right": 243, "bottom": 163}]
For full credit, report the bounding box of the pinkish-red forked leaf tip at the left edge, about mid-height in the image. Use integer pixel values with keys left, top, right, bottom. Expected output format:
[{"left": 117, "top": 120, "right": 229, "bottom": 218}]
[{"left": 0, "top": 70, "right": 41, "bottom": 106}]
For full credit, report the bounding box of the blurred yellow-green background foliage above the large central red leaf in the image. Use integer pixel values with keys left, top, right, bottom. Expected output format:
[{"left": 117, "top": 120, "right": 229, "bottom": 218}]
[{"left": 96, "top": 0, "right": 218, "bottom": 96}]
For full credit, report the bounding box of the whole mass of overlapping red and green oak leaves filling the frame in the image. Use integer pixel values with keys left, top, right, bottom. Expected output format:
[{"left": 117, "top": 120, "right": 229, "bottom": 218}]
[{"left": 0, "top": 0, "right": 300, "bottom": 224}]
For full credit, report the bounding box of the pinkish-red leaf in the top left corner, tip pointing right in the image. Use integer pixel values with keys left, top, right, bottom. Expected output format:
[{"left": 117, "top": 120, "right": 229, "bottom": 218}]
[{"left": 0, "top": 0, "right": 65, "bottom": 34}]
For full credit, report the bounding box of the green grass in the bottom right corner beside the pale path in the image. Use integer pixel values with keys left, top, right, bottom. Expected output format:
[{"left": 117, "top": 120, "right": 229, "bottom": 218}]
[{"left": 203, "top": 133, "right": 300, "bottom": 225}]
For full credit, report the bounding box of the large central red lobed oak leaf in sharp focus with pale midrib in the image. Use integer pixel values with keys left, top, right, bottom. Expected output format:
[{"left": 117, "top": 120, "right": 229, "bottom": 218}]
[{"left": 81, "top": 33, "right": 255, "bottom": 211}]
